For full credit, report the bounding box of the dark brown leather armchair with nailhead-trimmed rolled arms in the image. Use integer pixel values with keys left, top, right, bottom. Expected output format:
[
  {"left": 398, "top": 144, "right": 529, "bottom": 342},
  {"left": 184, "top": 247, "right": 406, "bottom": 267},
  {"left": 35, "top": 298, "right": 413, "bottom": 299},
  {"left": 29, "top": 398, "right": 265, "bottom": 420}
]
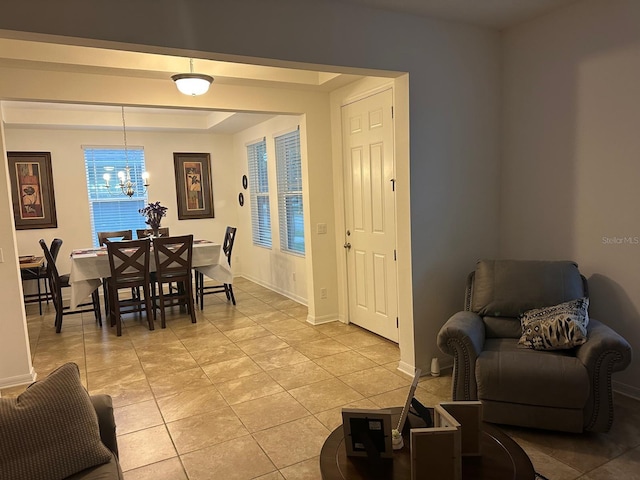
[{"left": 438, "top": 260, "right": 631, "bottom": 432}]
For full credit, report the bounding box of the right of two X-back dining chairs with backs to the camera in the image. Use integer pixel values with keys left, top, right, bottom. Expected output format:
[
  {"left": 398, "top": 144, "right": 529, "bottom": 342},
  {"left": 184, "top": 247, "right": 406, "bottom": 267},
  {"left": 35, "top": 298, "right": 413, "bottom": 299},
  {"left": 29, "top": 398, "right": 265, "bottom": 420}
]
[{"left": 153, "top": 235, "right": 196, "bottom": 328}]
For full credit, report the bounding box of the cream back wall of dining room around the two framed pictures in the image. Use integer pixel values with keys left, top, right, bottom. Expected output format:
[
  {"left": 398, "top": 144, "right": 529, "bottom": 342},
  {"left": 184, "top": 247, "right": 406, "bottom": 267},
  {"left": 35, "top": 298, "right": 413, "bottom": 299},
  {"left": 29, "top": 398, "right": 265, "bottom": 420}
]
[{"left": 5, "top": 128, "right": 237, "bottom": 272}]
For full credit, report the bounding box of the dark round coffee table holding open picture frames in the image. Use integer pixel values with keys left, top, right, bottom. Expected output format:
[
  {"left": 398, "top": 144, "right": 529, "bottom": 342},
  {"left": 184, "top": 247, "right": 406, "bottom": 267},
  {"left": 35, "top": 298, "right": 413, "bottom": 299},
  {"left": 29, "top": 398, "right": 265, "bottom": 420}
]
[{"left": 320, "top": 409, "right": 535, "bottom": 480}]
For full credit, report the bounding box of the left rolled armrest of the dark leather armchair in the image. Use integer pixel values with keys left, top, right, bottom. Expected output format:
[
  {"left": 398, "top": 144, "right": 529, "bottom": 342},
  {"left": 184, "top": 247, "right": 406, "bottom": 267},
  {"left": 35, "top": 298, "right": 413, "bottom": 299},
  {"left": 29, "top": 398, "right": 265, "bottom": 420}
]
[{"left": 438, "top": 311, "right": 485, "bottom": 400}]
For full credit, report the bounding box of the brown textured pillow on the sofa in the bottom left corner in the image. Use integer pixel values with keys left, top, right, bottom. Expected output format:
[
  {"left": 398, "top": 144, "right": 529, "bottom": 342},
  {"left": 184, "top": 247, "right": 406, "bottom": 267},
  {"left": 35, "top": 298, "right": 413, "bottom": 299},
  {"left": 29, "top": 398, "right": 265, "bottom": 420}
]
[{"left": 0, "top": 363, "right": 111, "bottom": 480}]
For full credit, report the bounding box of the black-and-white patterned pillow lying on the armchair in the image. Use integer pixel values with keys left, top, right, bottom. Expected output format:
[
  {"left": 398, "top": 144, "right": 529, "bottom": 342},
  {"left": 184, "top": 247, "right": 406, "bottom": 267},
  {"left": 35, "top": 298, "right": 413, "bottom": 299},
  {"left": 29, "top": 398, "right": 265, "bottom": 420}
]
[{"left": 518, "top": 297, "right": 589, "bottom": 350}]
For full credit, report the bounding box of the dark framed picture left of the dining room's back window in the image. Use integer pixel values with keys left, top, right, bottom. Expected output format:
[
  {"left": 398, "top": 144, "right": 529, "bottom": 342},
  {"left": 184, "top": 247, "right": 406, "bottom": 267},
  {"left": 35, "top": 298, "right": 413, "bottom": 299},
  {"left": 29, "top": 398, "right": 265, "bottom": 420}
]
[{"left": 7, "top": 152, "right": 58, "bottom": 230}]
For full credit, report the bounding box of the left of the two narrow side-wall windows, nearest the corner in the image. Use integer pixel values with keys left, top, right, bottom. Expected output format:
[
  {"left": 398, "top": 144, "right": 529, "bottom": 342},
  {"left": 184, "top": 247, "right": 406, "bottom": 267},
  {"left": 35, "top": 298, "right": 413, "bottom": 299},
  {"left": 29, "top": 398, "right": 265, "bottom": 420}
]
[{"left": 247, "top": 139, "right": 271, "bottom": 248}]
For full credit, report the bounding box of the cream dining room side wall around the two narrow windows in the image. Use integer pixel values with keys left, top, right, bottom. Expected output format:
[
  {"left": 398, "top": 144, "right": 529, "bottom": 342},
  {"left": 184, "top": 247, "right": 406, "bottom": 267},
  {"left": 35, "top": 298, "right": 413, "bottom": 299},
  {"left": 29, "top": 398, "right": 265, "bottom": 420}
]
[{"left": 233, "top": 115, "right": 307, "bottom": 304}]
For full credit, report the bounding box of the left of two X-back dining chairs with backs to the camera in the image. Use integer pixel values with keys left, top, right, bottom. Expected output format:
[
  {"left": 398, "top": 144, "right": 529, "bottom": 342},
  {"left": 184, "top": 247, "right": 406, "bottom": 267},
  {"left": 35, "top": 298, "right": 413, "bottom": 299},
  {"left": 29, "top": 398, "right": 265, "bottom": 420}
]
[{"left": 107, "top": 240, "right": 154, "bottom": 337}]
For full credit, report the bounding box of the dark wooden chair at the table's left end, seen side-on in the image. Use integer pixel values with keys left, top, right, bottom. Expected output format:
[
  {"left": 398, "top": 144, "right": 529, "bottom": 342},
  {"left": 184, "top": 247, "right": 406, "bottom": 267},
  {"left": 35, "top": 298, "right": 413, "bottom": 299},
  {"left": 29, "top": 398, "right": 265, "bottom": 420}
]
[{"left": 39, "top": 238, "right": 102, "bottom": 333}]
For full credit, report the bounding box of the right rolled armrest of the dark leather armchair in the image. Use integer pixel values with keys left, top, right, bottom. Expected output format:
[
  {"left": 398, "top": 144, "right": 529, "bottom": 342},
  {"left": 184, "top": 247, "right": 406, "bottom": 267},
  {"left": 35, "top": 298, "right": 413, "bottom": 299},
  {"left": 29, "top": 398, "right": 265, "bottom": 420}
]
[{"left": 576, "top": 318, "right": 632, "bottom": 432}]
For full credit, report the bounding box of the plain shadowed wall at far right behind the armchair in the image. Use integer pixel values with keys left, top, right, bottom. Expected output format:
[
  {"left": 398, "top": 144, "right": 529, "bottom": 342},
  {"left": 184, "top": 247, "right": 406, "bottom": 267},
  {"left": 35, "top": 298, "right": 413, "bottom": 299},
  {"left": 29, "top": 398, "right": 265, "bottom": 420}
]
[{"left": 500, "top": 0, "right": 640, "bottom": 397}]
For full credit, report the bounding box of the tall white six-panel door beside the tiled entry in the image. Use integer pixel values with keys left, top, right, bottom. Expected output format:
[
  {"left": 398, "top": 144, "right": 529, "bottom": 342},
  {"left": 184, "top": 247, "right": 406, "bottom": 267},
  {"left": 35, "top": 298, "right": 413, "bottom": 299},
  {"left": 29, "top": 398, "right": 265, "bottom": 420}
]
[{"left": 342, "top": 89, "right": 398, "bottom": 342}]
